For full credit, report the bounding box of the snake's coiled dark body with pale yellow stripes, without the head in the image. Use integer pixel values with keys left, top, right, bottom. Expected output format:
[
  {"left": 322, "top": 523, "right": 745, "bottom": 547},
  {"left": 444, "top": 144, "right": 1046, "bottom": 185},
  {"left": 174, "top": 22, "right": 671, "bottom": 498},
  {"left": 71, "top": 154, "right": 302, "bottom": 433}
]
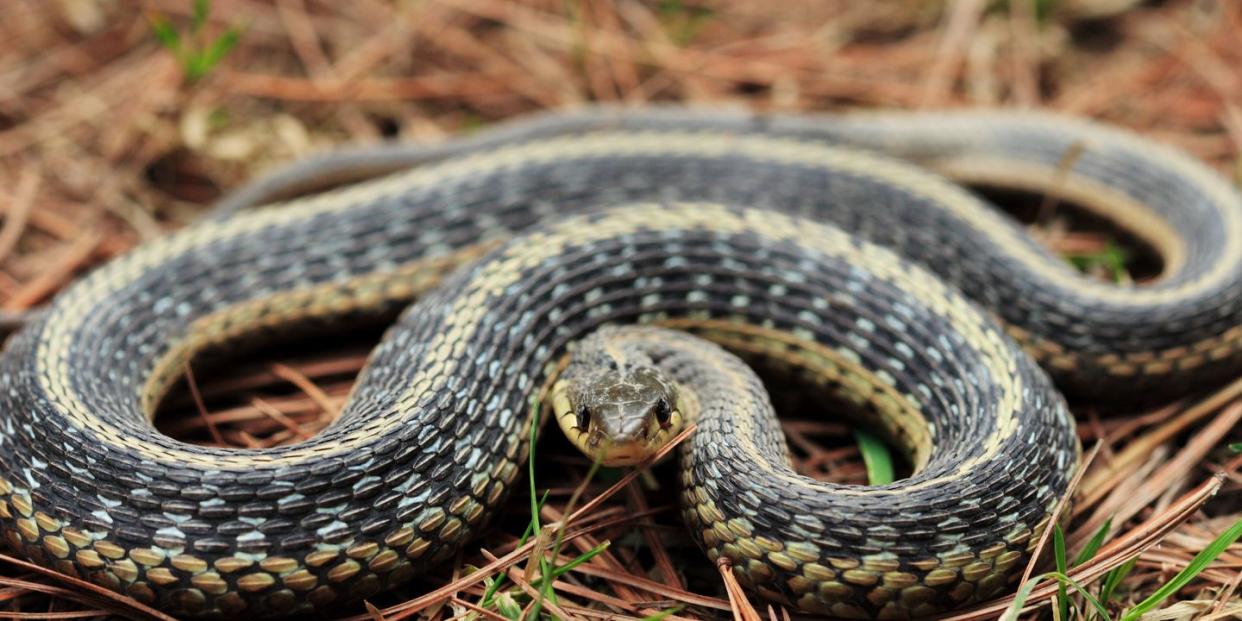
[{"left": 0, "top": 109, "right": 1242, "bottom": 617}]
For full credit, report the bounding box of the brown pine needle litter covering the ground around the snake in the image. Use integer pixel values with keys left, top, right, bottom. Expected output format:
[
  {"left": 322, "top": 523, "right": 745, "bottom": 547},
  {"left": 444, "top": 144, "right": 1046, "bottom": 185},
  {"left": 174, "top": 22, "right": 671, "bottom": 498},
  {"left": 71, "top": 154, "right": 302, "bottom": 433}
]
[{"left": 0, "top": 0, "right": 1242, "bottom": 621}]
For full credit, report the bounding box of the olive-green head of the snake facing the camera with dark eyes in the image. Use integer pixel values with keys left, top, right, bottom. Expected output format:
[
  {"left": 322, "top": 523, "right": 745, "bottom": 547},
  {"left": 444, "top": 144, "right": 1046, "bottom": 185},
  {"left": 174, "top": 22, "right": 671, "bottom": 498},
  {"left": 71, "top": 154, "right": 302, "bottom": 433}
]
[{"left": 551, "top": 342, "right": 683, "bottom": 466}]
